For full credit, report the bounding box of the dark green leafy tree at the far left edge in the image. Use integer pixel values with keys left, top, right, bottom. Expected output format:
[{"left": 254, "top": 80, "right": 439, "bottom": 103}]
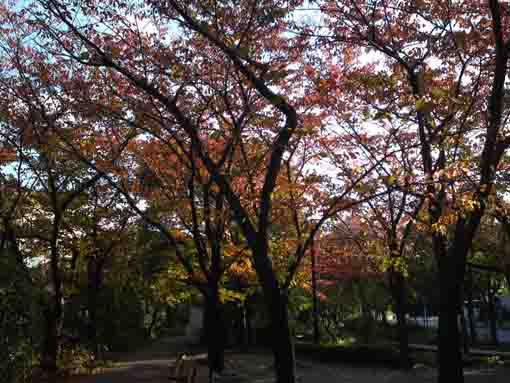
[{"left": 0, "top": 152, "right": 42, "bottom": 382}]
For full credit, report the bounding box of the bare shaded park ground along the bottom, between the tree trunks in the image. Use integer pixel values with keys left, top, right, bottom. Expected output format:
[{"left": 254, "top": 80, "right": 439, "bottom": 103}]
[{"left": 55, "top": 338, "right": 510, "bottom": 383}]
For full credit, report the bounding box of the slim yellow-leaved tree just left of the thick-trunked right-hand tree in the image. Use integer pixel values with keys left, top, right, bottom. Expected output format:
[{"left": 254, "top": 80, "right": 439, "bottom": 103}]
[{"left": 328, "top": 127, "right": 424, "bottom": 368}]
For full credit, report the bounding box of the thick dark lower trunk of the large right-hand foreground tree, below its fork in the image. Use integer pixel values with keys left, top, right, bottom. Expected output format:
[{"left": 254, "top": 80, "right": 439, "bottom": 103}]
[{"left": 438, "top": 254, "right": 464, "bottom": 383}]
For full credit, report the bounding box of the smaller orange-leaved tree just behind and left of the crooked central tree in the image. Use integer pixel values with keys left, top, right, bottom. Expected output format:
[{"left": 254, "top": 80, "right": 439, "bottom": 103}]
[{"left": 129, "top": 138, "right": 245, "bottom": 372}]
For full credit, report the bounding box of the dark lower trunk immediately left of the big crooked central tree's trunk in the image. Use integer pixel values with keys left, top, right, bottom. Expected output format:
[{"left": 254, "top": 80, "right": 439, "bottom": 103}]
[{"left": 204, "top": 286, "right": 226, "bottom": 372}]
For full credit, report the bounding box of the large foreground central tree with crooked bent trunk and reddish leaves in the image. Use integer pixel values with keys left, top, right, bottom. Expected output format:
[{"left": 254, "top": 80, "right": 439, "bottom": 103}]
[{"left": 26, "top": 0, "right": 378, "bottom": 382}]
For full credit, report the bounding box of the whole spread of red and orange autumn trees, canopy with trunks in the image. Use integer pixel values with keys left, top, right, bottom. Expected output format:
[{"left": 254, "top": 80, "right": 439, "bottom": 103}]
[{"left": 0, "top": 0, "right": 510, "bottom": 383}]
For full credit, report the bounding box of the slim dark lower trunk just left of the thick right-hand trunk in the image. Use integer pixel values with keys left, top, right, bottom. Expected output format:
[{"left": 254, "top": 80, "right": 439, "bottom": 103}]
[{"left": 391, "top": 272, "right": 411, "bottom": 368}]
